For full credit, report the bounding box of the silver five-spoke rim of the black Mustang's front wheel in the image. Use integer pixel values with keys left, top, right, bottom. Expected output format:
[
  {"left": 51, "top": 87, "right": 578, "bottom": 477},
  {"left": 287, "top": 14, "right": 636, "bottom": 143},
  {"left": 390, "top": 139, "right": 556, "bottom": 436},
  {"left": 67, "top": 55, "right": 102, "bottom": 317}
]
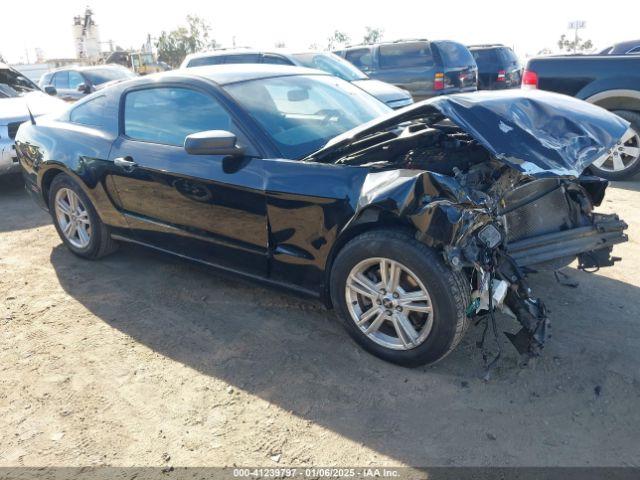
[{"left": 345, "top": 257, "right": 433, "bottom": 350}]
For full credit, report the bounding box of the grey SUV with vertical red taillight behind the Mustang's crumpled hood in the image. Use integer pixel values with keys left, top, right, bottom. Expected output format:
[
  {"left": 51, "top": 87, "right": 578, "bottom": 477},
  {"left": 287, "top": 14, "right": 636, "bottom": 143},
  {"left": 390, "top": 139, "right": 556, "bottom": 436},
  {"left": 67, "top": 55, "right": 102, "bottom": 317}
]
[{"left": 335, "top": 40, "right": 478, "bottom": 101}]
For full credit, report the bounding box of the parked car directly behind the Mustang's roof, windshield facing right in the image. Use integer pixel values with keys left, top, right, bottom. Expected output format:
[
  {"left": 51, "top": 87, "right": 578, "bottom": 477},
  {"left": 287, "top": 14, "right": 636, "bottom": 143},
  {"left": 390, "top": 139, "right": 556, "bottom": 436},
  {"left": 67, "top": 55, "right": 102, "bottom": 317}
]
[{"left": 180, "top": 49, "right": 413, "bottom": 108}]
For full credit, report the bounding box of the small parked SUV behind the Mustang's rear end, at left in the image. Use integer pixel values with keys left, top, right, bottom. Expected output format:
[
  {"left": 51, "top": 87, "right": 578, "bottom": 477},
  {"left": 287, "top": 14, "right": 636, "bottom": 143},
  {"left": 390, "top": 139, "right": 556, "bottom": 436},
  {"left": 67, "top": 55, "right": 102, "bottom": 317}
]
[{"left": 40, "top": 65, "right": 136, "bottom": 101}]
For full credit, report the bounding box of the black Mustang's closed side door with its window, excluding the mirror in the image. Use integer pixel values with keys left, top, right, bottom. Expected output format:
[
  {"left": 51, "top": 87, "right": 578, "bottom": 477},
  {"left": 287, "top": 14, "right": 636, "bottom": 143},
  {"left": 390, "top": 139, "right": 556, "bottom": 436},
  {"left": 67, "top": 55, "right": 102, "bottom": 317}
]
[{"left": 110, "top": 84, "right": 268, "bottom": 276}]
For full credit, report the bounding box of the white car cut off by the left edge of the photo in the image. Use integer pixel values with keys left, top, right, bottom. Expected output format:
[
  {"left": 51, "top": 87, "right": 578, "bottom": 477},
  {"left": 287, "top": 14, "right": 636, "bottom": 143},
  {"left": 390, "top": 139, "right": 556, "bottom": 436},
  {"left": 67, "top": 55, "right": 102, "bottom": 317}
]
[{"left": 0, "top": 63, "right": 64, "bottom": 175}]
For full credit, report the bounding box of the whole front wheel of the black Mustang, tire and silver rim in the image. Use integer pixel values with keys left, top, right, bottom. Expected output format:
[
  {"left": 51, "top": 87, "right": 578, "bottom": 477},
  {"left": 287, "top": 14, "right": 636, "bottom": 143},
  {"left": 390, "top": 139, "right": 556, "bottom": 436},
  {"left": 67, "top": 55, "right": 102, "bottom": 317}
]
[{"left": 331, "top": 230, "right": 469, "bottom": 367}]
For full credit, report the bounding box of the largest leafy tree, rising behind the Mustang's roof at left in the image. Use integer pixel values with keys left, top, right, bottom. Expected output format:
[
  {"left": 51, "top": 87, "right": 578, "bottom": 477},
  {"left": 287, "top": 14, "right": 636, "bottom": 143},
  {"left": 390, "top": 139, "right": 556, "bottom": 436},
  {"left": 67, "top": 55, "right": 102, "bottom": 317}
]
[{"left": 156, "top": 15, "right": 218, "bottom": 67}]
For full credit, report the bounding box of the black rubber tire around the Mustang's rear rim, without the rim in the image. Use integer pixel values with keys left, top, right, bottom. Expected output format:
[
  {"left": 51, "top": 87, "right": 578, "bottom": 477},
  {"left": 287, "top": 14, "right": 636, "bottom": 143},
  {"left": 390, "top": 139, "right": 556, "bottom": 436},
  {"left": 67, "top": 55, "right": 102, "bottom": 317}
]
[{"left": 49, "top": 173, "right": 118, "bottom": 260}]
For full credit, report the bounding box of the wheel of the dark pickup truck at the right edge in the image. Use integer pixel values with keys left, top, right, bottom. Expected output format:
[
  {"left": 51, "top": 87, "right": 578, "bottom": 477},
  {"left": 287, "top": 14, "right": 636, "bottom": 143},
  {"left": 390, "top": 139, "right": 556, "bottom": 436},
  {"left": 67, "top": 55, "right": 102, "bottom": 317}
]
[{"left": 591, "top": 110, "right": 640, "bottom": 180}]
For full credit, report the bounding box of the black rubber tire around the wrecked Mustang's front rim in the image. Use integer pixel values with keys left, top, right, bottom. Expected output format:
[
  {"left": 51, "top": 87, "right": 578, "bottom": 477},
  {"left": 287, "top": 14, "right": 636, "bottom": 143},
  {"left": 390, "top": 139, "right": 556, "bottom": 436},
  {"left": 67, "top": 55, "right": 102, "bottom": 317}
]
[{"left": 330, "top": 229, "right": 469, "bottom": 367}]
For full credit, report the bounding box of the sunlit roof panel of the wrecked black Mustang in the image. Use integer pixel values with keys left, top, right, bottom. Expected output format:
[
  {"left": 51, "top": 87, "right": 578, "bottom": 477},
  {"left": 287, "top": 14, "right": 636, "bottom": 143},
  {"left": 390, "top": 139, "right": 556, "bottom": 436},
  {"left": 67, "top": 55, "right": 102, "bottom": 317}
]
[{"left": 175, "top": 63, "right": 329, "bottom": 85}]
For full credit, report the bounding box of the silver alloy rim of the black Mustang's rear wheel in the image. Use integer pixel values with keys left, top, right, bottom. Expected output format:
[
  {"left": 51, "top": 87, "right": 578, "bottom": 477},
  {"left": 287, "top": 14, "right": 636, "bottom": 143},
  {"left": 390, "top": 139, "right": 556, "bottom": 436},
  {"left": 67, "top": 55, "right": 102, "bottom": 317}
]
[{"left": 55, "top": 188, "right": 91, "bottom": 248}]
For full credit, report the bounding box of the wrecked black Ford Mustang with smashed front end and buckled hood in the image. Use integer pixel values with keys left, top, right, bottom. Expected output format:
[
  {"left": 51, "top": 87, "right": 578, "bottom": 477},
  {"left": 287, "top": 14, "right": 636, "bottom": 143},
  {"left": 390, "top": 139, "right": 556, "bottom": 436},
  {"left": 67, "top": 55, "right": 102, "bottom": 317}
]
[{"left": 17, "top": 65, "right": 628, "bottom": 366}]
